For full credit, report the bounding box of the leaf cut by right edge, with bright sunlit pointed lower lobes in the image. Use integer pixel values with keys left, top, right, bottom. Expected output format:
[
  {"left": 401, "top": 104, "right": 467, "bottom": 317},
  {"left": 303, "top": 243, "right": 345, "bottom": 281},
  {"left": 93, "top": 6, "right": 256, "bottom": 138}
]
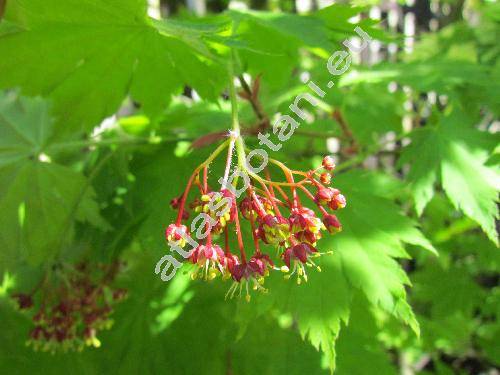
[{"left": 401, "top": 110, "right": 500, "bottom": 242}]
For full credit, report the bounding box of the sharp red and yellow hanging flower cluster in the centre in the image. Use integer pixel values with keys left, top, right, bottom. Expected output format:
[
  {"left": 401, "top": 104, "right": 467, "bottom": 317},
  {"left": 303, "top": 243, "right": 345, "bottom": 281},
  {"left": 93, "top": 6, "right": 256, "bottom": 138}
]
[{"left": 165, "top": 137, "right": 346, "bottom": 300}]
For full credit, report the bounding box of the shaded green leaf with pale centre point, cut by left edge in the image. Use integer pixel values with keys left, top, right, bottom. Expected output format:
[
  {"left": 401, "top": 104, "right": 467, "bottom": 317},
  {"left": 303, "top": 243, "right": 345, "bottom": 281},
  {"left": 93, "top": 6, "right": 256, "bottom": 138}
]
[{"left": 0, "top": 93, "right": 107, "bottom": 268}]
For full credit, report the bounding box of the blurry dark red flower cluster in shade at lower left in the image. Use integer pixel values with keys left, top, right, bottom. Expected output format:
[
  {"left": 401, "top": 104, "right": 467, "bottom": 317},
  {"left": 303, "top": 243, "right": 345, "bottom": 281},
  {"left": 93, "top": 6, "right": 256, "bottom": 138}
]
[{"left": 11, "top": 262, "right": 127, "bottom": 353}]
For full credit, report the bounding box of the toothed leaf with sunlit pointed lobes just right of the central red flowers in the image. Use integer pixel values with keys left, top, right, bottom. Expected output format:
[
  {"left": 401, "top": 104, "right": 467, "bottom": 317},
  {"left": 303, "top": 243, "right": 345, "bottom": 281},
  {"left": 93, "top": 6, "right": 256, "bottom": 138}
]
[{"left": 323, "top": 171, "right": 435, "bottom": 333}]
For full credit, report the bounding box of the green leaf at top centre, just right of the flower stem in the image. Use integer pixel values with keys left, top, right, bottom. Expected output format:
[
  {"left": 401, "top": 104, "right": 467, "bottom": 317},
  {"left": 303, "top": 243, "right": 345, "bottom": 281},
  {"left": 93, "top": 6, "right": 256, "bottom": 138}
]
[{"left": 229, "top": 4, "right": 383, "bottom": 88}]
